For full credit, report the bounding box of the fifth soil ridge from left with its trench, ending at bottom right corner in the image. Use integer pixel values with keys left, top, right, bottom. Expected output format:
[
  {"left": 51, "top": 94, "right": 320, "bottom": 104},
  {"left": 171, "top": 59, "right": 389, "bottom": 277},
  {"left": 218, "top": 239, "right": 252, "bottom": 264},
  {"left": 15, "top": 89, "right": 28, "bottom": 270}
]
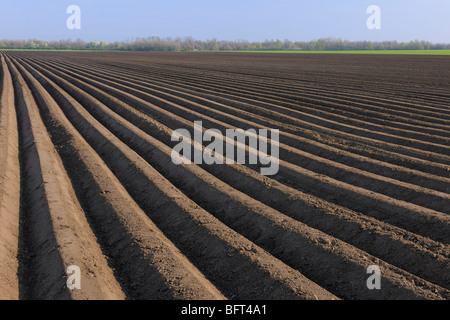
[{"left": 20, "top": 57, "right": 447, "bottom": 298}]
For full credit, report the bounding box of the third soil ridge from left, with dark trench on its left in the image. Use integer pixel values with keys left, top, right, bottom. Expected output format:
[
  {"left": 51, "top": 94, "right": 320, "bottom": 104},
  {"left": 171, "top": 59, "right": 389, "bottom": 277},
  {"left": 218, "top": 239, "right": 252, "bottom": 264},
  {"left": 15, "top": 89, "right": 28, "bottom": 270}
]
[{"left": 10, "top": 57, "right": 224, "bottom": 300}]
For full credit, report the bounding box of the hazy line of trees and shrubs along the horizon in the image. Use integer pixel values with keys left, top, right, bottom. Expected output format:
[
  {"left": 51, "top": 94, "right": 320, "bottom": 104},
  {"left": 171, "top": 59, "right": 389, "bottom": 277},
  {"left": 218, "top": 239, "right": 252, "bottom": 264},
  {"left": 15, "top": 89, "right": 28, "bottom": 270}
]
[{"left": 0, "top": 37, "right": 450, "bottom": 51}]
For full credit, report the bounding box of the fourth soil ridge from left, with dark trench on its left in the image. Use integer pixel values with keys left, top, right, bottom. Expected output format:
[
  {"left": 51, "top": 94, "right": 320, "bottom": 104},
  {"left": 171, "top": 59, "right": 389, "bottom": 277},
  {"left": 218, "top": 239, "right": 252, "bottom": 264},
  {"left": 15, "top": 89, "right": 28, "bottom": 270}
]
[{"left": 16, "top": 54, "right": 338, "bottom": 299}]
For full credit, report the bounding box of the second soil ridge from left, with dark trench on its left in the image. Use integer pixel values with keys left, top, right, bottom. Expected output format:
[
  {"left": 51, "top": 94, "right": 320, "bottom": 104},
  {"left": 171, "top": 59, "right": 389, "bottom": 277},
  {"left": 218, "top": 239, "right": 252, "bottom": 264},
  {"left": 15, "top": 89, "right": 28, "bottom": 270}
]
[{"left": 8, "top": 55, "right": 123, "bottom": 299}]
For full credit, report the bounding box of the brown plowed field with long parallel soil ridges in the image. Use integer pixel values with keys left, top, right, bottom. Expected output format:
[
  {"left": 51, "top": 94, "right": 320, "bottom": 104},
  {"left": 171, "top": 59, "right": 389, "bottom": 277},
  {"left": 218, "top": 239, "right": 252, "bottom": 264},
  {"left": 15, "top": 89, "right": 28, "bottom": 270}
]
[{"left": 0, "top": 52, "right": 450, "bottom": 300}]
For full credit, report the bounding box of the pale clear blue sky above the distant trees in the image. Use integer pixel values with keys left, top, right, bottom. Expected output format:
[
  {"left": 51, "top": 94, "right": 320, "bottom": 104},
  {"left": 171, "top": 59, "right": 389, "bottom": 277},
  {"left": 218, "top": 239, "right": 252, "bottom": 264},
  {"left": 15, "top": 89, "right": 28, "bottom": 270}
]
[{"left": 0, "top": 0, "right": 450, "bottom": 43}]
